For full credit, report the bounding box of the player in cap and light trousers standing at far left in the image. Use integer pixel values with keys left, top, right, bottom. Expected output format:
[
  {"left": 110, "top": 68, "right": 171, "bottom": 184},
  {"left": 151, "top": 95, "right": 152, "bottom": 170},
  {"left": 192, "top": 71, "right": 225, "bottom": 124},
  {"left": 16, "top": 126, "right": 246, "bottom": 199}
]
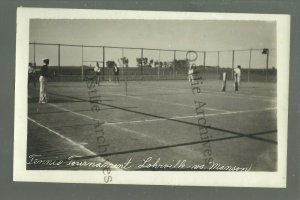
[{"left": 39, "top": 58, "right": 49, "bottom": 103}]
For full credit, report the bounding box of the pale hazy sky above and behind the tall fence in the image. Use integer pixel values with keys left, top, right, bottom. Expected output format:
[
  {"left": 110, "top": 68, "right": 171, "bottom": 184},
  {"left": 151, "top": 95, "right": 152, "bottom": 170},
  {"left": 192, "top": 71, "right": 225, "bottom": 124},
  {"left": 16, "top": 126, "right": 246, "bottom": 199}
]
[{"left": 29, "top": 19, "right": 276, "bottom": 68}]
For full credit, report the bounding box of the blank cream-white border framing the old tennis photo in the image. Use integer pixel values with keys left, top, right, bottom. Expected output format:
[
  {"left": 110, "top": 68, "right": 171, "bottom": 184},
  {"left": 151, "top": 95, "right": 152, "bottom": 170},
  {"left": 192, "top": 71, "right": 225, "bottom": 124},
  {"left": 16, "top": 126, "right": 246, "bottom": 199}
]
[{"left": 13, "top": 7, "right": 290, "bottom": 188}]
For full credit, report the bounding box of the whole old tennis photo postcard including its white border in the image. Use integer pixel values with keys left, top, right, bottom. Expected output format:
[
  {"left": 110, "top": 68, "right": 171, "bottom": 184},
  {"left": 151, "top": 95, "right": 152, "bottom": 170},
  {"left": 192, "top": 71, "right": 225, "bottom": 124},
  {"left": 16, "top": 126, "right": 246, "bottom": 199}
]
[{"left": 14, "top": 8, "right": 290, "bottom": 187}]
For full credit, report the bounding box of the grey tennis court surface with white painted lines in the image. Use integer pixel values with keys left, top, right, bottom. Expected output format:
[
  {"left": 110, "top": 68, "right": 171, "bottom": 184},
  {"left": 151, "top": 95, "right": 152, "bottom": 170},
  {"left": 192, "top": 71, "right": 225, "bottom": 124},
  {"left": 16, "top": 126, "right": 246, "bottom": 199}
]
[{"left": 27, "top": 80, "right": 277, "bottom": 171}]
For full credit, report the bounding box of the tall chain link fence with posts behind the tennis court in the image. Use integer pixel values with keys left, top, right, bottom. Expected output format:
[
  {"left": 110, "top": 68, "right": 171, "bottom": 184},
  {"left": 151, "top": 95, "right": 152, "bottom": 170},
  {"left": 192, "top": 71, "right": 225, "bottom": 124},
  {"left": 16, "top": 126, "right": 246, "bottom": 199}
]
[{"left": 29, "top": 42, "right": 277, "bottom": 82}]
